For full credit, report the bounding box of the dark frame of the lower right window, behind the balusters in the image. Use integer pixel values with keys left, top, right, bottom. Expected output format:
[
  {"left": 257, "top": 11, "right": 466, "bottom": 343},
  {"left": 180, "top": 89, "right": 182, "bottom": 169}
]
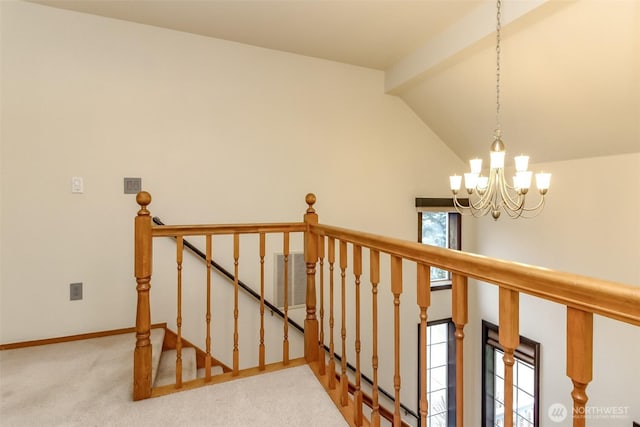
[{"left": 482, "top": 319, "right": 540, "bottom": 427}]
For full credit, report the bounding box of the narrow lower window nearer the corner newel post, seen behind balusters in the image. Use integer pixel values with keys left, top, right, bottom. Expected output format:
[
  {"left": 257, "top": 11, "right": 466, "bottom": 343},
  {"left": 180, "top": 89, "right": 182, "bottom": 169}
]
[{"left": 417, "top": 319, "right": 456, "bottom": 427}]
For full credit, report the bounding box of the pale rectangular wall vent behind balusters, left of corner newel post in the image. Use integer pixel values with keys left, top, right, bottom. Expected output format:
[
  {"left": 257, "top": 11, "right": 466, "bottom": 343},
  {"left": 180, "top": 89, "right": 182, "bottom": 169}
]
[{"left": 274, "top": 252, "right": 307, "bottom": 308}]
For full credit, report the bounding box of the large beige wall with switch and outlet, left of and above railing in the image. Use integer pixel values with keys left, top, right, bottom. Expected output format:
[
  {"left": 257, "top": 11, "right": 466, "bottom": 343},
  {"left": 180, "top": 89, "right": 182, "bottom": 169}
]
[{"left": 0, "top": 1, "right": 462, "bottom": 343}]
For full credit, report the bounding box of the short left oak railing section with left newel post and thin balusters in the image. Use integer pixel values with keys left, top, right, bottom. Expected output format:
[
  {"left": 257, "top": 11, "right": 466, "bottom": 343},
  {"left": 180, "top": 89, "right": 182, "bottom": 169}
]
[{"left": 133, "top": 192, "right": 308, "bottom": 400}]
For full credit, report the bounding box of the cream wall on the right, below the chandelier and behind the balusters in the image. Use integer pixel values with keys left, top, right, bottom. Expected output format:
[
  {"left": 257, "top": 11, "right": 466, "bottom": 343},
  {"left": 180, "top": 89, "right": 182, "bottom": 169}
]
[{"left": 466, "top": 153, "right": 640, "bottom": 427}]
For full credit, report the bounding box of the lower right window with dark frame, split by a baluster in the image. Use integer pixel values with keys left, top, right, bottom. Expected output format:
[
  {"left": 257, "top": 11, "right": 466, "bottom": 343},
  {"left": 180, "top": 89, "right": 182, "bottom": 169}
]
[{"left": 482, "top": 320, "right": 540, "bottom": 427}]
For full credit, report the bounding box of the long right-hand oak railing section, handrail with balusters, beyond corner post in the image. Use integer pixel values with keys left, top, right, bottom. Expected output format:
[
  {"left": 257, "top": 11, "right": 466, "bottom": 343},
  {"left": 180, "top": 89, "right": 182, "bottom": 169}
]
[{"left": 310, "top": 209, "right": 640, "bottom": 427}]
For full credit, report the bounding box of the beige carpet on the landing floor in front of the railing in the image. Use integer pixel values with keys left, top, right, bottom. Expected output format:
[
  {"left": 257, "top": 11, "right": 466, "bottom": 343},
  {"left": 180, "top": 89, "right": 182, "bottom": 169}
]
[{"left": 0, "top": 334, "right": 348, "bottom": 427}]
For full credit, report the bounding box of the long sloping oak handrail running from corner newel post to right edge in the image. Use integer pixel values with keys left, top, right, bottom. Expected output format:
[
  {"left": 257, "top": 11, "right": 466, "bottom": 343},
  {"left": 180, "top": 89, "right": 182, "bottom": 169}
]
[{"left": 310, "top": 224, "right": 640, "bottom": 326}]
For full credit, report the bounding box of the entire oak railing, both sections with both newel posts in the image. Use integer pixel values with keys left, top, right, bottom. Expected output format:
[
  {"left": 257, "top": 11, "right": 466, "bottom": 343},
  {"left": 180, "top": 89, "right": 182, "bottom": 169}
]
[{"left": 134, "top": 192, "right": 640, "bottom": 426}]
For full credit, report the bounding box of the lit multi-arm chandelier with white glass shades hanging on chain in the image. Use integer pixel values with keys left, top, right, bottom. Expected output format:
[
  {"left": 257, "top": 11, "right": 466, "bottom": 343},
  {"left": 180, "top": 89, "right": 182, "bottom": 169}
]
[{"left": 449, "top": 0, "right": 551, "bottom": 220}]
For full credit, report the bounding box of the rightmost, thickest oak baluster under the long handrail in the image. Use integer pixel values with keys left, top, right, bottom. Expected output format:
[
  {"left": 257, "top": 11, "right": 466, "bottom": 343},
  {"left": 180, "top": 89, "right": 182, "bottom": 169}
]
[{"left": 567, "top": 307, "right": 593, "bottom": 427}]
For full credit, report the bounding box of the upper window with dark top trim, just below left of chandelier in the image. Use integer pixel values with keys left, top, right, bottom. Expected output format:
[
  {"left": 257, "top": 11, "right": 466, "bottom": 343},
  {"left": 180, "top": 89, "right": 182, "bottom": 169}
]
[{"left": 416, "top": 198, "right": 462, "bottom": 289}]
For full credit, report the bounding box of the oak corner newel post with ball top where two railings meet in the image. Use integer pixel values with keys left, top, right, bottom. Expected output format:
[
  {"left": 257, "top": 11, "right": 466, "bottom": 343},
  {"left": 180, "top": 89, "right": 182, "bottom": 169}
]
[{"left": 304, "top": 193, "right": 319, "bottom": 362}]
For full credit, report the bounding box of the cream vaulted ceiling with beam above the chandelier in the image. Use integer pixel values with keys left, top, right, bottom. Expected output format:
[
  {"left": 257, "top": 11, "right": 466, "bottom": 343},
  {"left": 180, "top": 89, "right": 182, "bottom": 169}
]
[{"left": 30, "top": 0, "right": 640, "bottom": 166}]
